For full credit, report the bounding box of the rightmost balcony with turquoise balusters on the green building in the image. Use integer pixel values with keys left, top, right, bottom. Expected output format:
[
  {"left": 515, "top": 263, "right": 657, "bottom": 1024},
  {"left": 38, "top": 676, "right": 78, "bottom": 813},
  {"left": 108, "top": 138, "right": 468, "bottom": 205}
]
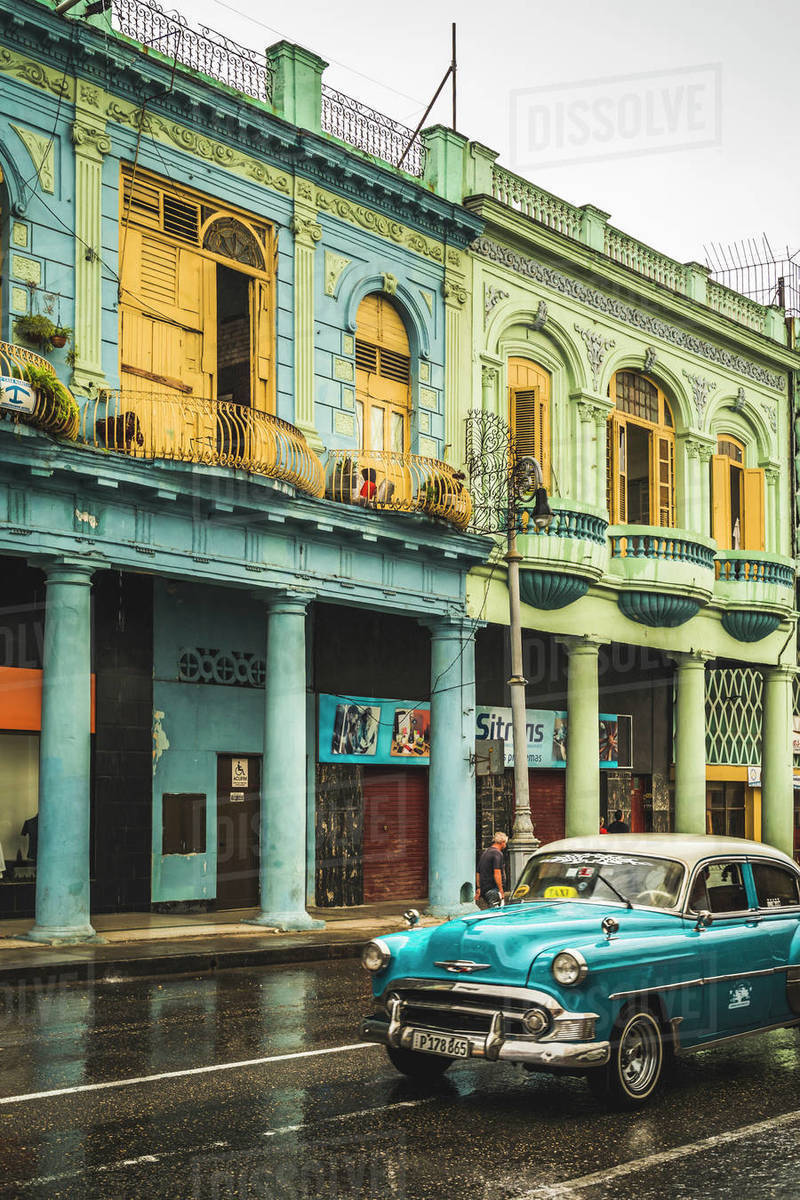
[{"left": 714, "top": 550, "right": 795, "bottom": 642}]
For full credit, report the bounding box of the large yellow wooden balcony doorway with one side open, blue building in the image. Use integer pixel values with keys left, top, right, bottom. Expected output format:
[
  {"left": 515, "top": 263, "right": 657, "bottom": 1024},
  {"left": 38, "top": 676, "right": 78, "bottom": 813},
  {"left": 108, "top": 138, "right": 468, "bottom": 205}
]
[{"left": 120, "top": 166, "right": 275, "bottom": 424}]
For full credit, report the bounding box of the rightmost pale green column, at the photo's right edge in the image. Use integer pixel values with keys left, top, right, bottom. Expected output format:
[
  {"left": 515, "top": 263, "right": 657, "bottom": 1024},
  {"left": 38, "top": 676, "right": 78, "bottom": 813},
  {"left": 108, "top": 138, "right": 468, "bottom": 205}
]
[{"left": 762, "top": 666, "right": 795, "bottom": 854}]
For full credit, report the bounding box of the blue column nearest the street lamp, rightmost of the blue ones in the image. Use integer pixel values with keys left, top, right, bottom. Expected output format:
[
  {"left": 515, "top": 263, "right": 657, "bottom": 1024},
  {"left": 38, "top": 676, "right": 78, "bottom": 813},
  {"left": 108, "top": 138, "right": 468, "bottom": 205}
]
[{"left": 428, "top": 617, "right": 476, "bottom": 917}]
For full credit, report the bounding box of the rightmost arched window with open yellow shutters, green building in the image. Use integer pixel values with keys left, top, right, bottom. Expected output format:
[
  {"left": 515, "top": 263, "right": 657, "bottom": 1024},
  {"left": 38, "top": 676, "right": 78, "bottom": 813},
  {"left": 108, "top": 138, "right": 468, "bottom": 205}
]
[{"left": 711, "top": 433, "right": 764, "bottom": 550}]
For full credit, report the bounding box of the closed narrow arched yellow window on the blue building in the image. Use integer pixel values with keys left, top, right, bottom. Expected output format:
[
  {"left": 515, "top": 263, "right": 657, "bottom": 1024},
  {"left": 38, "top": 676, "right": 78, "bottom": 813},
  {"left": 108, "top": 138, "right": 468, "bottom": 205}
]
[{"left": 355, "top": 295, "right": 411, "bottom": 454}]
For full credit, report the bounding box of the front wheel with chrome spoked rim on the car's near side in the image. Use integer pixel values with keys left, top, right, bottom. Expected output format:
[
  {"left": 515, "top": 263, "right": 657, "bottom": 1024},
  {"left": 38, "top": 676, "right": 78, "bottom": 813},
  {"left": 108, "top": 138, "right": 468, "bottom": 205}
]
[{"left": 588, "top": 1008, "right": 664, "bottom": 1108}]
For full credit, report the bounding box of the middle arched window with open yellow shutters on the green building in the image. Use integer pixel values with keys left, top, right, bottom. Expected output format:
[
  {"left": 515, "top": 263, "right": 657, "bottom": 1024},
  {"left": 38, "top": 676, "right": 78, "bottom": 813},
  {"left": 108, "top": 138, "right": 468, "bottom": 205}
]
[{"left": 607, "top": 371, "right": 675, "bottom": 526}]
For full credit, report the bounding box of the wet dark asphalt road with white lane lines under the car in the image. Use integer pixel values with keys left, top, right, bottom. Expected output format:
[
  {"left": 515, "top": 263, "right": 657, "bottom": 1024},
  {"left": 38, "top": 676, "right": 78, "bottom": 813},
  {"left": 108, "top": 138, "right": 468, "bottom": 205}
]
[{"left": 0, "top": 962, "right": 800, "bottom": 1200}]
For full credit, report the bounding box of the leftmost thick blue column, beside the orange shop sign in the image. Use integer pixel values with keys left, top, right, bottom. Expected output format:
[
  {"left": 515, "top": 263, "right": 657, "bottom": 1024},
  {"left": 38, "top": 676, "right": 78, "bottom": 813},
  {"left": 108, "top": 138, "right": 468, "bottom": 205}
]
[{"left": 28, "top": 563, "right": 95, "bottom": 942}]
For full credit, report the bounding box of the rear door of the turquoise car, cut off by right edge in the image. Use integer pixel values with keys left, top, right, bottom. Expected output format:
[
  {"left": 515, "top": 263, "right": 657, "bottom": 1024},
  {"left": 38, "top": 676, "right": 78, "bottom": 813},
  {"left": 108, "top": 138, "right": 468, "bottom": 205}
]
[{"left": 750, "top": 858, "right": 800, "bottom": 1024}]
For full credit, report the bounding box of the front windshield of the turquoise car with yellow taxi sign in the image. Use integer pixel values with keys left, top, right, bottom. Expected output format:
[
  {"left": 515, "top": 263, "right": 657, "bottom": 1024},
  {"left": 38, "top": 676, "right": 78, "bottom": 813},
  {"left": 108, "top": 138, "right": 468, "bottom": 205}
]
[{"left": 511, "top": 851, "right": 684, "bottom": 908}]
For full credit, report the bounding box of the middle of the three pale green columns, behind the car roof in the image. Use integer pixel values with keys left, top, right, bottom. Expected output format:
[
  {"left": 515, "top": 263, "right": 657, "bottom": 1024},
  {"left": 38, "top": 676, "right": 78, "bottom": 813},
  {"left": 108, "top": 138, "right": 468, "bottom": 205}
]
[{"left": 669, "top": 653, "right": 709, "bottom": 833}]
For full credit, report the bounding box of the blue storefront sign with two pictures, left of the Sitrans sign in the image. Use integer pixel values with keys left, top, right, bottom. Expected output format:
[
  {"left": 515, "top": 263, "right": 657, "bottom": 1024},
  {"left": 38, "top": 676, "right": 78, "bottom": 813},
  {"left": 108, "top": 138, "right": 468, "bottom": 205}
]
[{"left": 319, "top": 695, "right": 431, "bottom": 767}]
